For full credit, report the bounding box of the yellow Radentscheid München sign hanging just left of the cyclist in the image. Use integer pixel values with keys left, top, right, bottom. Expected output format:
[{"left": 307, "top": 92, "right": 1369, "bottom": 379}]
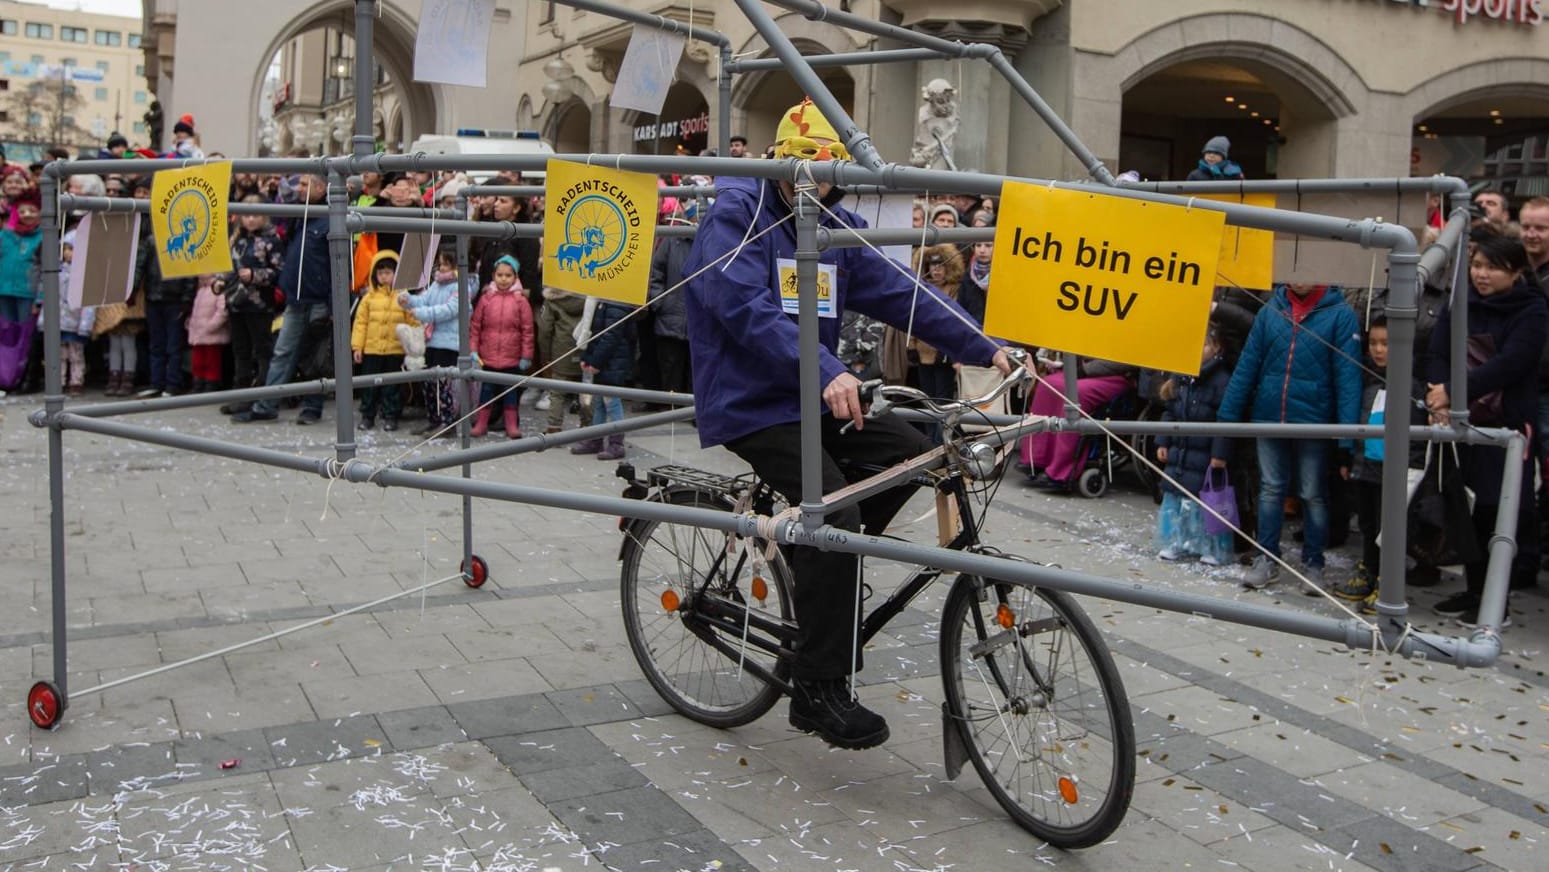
[{"left": 544, "top": 161, "right": 657, "bottom": 305}]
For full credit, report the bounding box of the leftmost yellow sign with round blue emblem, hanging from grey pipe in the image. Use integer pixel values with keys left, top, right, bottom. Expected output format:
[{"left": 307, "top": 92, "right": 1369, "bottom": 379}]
[{"left": 150, "top": 161, "right": 231, "bottom": 279}]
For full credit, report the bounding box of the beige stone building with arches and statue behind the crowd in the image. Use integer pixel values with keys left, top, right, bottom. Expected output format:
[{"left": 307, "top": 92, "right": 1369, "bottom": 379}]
[{"left": 146, "top": 0, "right": 1549, "bottom": 195}]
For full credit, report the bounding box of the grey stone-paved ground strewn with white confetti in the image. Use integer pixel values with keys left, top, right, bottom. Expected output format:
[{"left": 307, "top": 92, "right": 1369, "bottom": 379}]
[{"left": 0, "top": 397, "right": 1549, "bottom": 872}]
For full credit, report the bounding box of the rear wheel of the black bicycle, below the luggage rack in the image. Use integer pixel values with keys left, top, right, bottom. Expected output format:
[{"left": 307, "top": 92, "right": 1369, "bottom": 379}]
[{"left": 620, "top": 491, "right": 792, "bottom": 728}]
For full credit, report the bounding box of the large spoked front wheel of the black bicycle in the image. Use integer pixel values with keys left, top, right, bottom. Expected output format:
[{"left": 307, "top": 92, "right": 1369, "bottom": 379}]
[{"left": 940, "top": 578, "right": 1135, "bottom": 849}]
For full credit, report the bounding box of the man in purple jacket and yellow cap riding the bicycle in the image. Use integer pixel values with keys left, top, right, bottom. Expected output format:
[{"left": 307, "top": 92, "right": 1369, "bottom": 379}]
[{"left": 683, "top": 101, "right": 1011, "bottom": 748}]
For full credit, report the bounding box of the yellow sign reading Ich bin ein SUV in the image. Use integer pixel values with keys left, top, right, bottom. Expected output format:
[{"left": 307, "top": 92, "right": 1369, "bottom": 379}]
[{"left": 984, "top": 181, "right": 1225, "bottom": 373}]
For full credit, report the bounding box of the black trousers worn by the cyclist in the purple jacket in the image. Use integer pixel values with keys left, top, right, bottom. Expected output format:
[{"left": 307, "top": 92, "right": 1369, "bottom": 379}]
[{"left": 726, "top": 415, "right": 931, "bottom": 681}]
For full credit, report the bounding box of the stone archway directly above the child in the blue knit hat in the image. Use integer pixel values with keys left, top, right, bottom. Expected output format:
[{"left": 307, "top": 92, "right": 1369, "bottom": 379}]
[{"left": 1090, "top": 14, "right": 1366, "bottom": 178}]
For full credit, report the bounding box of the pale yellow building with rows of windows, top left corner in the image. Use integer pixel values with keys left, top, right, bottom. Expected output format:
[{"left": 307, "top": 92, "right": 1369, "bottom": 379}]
[{"left": 0, "top": 0, "right": 153, "bottom": 160}]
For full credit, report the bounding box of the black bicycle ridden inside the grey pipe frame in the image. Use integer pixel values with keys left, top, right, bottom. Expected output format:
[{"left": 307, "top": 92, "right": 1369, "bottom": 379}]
[{"left": 620, "top": 369, "right": 1135, "bottom": 849}]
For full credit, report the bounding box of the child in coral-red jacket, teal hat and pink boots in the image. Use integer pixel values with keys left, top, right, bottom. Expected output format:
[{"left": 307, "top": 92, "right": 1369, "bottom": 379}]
[{"left": 468, "top": 254, "right": 536, "bottom": 438}]
